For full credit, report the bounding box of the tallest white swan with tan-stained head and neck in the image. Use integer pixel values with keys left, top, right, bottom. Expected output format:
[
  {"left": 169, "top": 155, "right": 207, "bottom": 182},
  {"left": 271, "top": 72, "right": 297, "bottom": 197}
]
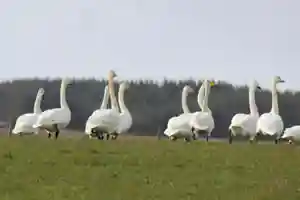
[{"left": 89, "top": 70, "right": 120, "bottom": 139}]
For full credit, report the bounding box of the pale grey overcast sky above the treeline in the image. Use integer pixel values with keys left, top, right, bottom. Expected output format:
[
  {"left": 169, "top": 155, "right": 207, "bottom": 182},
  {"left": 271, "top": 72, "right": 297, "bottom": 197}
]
[{"left": 0, "top": 0, "right": 300, "bottom": 90}]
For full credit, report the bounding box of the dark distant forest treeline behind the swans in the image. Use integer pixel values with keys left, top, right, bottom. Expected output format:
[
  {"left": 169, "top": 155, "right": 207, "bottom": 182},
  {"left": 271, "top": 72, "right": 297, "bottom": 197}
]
[{"left": 0, "top": 79, "right": 300, "bottom": 137}]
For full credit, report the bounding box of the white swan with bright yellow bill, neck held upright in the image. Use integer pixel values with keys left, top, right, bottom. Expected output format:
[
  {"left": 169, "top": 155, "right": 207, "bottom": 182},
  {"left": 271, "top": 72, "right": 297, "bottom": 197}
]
[{"left": 189, "top": 80, "right": 215, "bottom": 141}]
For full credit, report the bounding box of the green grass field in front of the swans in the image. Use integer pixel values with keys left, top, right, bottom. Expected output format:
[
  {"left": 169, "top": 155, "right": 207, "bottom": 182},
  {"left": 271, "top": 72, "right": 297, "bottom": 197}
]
[{"left": 0, "top": 136, "right": 300, "bottom": 200}]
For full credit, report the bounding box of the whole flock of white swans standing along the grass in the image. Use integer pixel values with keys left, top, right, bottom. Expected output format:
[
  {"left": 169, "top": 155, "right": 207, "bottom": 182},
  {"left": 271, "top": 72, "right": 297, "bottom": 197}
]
[{"left": 12, "top": 70, "right": 300, "bottom": 144}]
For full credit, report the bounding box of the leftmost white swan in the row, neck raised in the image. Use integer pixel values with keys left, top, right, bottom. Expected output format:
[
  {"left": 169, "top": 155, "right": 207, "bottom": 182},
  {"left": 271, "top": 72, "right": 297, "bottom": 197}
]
[{"left": 12, "top": 88, "right": 45, "bottom": 135}]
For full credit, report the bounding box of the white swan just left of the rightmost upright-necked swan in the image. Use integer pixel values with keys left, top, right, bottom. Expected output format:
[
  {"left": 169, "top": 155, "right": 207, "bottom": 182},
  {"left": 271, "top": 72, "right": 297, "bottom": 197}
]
[{"left": 229, "top": 80, "right": 261, "bottom": 144}]
